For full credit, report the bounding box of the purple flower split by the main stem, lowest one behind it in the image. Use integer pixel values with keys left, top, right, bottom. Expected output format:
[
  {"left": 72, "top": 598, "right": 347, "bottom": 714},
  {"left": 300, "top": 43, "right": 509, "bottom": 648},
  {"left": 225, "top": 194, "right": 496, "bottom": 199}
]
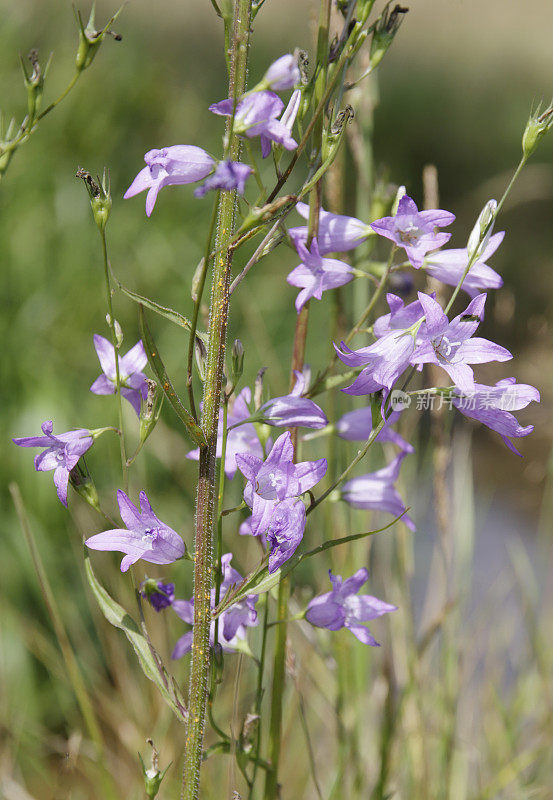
[{"left": 171, "top": 553, "right": 257, "bottom": 658}]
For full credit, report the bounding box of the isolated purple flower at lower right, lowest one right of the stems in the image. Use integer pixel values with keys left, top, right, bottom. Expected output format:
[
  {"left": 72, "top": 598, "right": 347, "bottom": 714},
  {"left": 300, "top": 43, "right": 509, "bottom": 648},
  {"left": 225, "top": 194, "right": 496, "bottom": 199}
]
[{"left": 305, "top": 567, "right": 397, "bottom": 647}]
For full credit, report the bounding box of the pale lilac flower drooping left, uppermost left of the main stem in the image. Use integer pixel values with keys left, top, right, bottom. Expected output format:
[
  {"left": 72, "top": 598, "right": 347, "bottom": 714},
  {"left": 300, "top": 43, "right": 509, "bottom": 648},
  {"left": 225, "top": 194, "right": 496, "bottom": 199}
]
[{"left": 123, "top": 144, "right": 215, "bottom": 216}]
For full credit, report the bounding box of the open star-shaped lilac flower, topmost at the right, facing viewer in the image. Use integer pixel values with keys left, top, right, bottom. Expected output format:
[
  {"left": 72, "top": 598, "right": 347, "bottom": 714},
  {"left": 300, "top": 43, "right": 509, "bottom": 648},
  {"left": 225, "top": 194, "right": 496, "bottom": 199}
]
[{"left": 371, "top": 195, "right": 455, "bottom": 269}]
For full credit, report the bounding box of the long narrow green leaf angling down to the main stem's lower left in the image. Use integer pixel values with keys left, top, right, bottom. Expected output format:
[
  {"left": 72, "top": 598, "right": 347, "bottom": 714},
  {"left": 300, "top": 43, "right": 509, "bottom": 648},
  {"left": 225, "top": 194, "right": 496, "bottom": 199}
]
[{"left": 84, "top": 548, "right": 187, "bottom": 722}]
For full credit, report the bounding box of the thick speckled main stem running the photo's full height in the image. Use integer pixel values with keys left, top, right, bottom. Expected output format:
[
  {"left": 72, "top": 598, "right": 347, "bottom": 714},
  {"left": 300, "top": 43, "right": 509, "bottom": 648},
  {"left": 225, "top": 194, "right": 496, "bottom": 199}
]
[{"left": 181, "top": 0, "right": 252, "bottom": 800}]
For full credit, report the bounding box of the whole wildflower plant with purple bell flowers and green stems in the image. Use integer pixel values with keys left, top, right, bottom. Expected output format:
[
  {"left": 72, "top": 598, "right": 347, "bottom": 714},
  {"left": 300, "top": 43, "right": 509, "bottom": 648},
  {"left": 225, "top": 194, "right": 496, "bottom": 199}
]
[{"left": 7, "top": 0, "right": 551, "bottom": 800}]
